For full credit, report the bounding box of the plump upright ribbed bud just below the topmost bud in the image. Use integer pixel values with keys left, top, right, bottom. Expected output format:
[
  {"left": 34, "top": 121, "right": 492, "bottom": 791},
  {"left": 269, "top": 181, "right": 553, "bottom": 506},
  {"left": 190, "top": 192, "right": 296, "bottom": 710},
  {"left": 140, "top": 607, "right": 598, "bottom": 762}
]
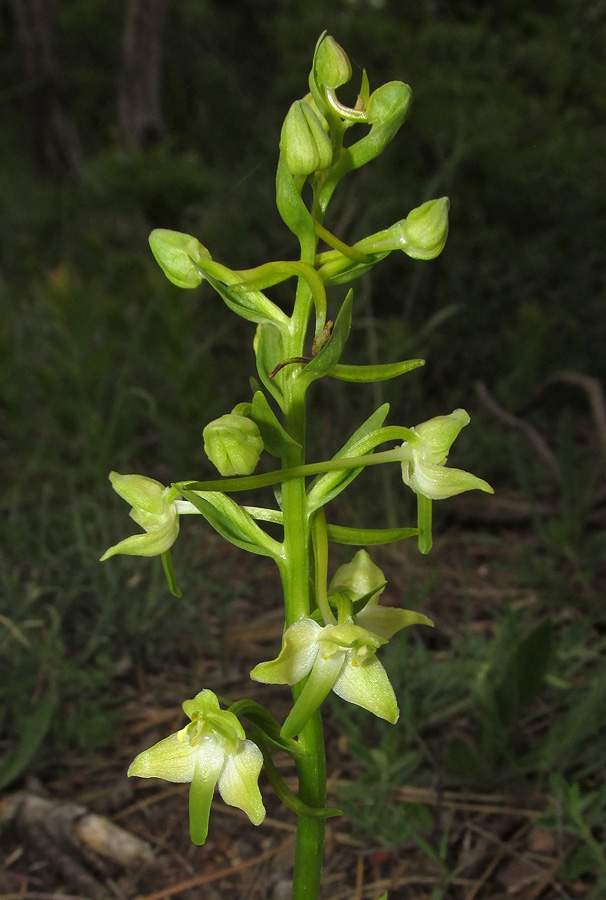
[{"left": 280, "top": 100, "right": 332, "bottom": 175}]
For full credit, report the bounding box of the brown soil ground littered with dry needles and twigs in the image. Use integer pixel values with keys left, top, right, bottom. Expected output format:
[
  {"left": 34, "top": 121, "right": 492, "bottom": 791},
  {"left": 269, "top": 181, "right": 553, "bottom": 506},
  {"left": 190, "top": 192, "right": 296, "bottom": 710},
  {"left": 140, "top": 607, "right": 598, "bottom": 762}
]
[{"left": 0, "top": 500, "right": 591, "bottom": 900}]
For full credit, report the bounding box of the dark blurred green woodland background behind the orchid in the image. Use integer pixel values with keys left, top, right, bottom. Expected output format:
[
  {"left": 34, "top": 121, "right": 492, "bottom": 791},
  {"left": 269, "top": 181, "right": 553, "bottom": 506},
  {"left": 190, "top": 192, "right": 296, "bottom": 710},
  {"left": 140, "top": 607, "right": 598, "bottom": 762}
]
[{"left": 0, "top": 0, "right": 606, "bottom": 884}]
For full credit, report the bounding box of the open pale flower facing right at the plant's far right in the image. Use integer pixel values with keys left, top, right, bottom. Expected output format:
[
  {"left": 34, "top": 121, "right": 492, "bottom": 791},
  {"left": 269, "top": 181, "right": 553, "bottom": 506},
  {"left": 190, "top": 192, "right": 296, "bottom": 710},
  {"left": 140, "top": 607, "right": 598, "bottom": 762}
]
[{"left": 401, "top": 409, "right": 494, "bottom": 500}]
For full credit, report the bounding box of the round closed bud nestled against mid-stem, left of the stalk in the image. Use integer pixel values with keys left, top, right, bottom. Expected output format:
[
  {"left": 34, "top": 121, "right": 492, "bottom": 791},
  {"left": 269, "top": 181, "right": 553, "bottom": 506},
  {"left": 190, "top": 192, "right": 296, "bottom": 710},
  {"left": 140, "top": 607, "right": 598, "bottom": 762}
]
[{"left": 203, "top": 413, "right": 263, "bottom": 476}]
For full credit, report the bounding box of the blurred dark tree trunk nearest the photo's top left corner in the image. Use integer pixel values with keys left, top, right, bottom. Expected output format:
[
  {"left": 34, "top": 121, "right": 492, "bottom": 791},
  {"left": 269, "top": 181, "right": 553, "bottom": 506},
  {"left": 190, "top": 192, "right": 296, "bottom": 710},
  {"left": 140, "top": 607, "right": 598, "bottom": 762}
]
[{"left": 13, "top": 0, "right": 82, "bottom": 179}]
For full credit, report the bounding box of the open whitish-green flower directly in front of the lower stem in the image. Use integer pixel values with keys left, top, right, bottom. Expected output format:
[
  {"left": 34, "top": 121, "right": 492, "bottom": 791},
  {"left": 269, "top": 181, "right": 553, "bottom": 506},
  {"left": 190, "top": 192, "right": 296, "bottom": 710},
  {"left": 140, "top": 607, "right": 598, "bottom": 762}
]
[{"left": 251, "top": 604, "right": 432, "bottom": 738}]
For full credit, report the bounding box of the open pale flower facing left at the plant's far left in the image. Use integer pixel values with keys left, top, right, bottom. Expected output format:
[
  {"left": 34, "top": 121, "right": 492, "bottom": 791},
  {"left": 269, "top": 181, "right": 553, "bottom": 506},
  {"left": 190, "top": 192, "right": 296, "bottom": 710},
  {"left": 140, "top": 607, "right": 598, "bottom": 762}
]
[{"left": 101, "top": 472, "right": 179, "bottom": 561}]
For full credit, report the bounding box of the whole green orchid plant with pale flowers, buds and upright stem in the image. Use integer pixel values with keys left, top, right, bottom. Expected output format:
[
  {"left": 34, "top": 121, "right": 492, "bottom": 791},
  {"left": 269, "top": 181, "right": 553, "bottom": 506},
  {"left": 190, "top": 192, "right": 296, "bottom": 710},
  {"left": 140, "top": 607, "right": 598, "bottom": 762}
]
[{"left": 102, "top": 35, "right": 492, "bottom": 900}]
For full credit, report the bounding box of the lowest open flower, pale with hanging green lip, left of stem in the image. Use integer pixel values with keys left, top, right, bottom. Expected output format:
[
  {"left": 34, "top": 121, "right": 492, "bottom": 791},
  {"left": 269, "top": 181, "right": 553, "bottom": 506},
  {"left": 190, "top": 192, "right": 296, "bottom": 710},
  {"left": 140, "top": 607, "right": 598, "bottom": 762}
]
[{"left": 128, "top": 691, "right": 265, "bottom": 844}]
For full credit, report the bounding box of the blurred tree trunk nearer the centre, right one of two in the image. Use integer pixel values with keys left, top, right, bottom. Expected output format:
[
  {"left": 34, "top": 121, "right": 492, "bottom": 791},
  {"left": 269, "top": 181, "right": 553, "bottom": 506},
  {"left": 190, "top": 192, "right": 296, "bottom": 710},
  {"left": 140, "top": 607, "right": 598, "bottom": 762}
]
[{"left": 118, "top": 0, "right": 168, "bottom": 150}]
